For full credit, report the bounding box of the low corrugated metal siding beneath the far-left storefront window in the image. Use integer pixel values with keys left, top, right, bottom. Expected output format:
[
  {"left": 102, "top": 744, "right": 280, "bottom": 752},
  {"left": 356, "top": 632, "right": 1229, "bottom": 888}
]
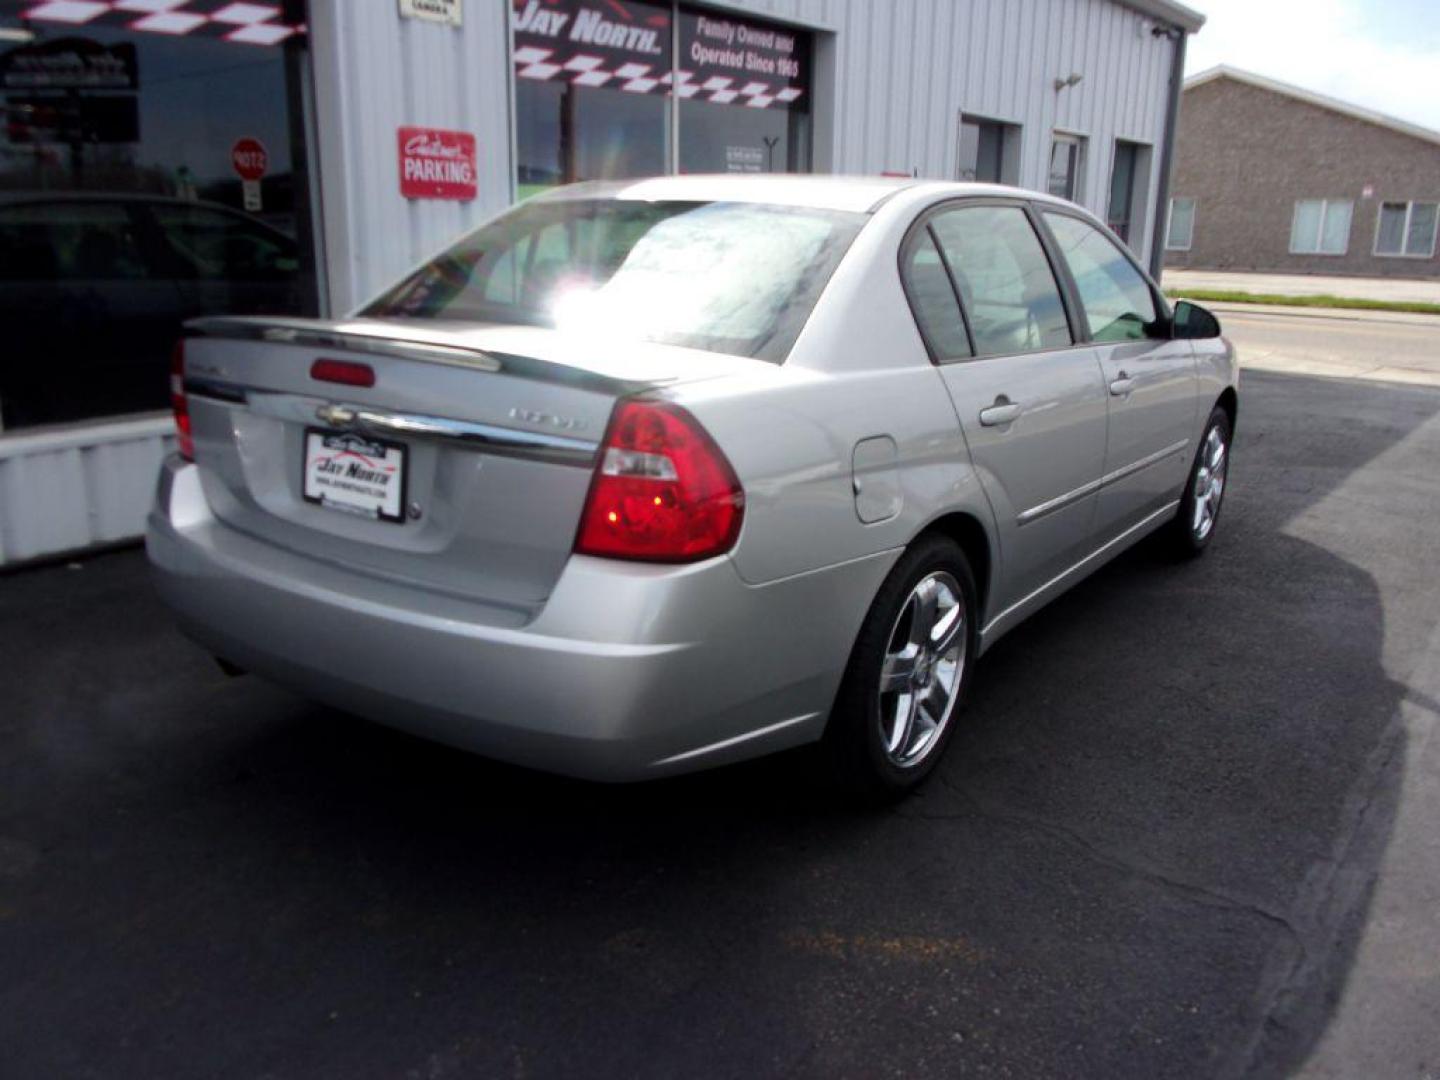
[{"left": 0, "top": 413, "right": 174, "bottom": 566}]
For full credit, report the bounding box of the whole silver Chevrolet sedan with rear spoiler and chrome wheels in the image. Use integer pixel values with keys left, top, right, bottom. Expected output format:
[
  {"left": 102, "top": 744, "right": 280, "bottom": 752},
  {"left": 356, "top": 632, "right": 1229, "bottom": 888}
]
[{"left": 147, "top": 177, "right": 1237, "bottom": 796}]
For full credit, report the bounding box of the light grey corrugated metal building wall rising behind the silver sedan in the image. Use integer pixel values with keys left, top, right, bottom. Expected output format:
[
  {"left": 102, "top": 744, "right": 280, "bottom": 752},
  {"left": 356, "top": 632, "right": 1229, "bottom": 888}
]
[{"left": 311, "top": 0, "right": 1174, "bottom": 311}]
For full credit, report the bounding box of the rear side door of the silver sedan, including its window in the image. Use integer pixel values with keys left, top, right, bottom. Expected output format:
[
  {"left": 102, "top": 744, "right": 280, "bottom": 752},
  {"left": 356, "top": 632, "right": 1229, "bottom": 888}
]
[{"left": 906, "top": 200, "right": 1106, "bottom": 618}]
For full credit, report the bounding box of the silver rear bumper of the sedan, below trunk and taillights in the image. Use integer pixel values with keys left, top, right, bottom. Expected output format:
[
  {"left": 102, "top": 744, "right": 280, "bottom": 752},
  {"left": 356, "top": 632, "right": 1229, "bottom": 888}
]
[{"left": 145, "top": 458, "right": 896, "bottom": 780}]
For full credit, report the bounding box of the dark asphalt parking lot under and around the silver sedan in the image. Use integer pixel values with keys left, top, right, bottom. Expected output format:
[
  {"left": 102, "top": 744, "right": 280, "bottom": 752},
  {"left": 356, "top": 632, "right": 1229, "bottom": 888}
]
[{"left": 0, "top": 361, "right": 1440, "bottom": 1077}]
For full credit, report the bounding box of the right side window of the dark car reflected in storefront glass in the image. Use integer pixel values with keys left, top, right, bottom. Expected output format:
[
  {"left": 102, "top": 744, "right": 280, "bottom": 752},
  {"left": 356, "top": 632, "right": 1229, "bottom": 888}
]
[{"left": 154, "top": 204, "right": 300, "bottom": 281}]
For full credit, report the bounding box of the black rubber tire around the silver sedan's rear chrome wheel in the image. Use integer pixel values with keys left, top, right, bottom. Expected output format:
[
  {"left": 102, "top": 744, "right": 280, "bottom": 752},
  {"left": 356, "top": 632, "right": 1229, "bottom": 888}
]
[{"left": 824, "top": 534, "right": 979, "bottom": 804}]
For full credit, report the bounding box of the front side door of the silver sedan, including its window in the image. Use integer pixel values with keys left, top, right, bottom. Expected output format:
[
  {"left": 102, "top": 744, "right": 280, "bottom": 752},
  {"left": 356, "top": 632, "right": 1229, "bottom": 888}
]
[{"left": 1041, "top": 209, "right": 1200, "bottom": 543}]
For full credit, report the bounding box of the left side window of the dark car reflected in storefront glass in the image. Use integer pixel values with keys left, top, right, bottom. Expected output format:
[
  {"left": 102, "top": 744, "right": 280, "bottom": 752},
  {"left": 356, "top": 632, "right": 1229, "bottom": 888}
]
[{"left": 0, "top": 202, "right": 148, "bottom": 281}]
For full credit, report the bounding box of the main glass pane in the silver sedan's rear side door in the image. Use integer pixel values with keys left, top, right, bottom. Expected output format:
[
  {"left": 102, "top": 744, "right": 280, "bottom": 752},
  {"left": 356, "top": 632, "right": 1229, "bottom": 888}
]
[{"left": 930, "top": 206, "right": 1071, "bottom": 356}]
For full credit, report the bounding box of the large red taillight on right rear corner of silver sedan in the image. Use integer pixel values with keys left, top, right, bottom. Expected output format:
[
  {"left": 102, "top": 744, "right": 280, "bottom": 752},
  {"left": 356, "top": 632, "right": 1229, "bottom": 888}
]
[{"left": 575, "top": 400, "right": 744, "bottom": 563}]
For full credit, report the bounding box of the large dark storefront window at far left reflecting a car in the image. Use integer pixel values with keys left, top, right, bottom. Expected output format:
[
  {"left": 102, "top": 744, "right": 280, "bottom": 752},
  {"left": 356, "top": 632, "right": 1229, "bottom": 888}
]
[{"left": 0, "top": 0, "right": 317, "bottom": 431}]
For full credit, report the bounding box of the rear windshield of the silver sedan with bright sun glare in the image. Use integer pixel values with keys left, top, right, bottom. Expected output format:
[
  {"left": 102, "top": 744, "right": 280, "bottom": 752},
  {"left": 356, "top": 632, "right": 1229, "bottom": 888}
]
[{"left": 360, "top": 199, "right": 865, "bottom": 363}]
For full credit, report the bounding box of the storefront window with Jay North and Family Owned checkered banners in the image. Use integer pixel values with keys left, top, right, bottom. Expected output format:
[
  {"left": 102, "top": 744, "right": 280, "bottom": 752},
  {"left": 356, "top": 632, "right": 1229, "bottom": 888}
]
[{"left": 514, "top": 0, "right": 811, "bottom": 197}]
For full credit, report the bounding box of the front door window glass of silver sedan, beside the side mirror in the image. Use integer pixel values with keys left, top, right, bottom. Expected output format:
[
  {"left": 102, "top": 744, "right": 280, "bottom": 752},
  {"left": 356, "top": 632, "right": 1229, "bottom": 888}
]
[{"left": 1045, "top": 213, "right": 1156, "bottom": 341}]
